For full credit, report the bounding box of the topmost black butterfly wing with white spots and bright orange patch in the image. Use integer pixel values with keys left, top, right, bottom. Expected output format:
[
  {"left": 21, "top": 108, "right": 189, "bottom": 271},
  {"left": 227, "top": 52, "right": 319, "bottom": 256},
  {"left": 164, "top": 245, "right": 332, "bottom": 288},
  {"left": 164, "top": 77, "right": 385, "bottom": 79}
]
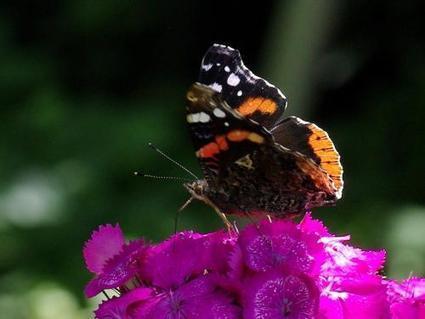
[{"left": 199, "top": 44, "right": 287, "bottom": 129}]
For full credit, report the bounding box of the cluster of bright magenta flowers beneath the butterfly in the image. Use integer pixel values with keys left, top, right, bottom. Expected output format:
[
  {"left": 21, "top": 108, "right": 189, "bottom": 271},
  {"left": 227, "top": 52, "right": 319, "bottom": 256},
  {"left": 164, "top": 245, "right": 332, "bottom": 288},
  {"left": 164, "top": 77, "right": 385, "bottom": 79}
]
[{"left": 84, "top": 214, "right": 425, "bottom": 319}]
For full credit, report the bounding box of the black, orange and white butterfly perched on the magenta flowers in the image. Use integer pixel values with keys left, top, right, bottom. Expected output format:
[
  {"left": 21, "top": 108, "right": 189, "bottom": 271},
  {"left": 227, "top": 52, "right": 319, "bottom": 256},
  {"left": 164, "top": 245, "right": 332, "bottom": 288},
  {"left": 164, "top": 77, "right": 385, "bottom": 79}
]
[{"left": 185, "top": 44, "right": 343, "bottom": 224}]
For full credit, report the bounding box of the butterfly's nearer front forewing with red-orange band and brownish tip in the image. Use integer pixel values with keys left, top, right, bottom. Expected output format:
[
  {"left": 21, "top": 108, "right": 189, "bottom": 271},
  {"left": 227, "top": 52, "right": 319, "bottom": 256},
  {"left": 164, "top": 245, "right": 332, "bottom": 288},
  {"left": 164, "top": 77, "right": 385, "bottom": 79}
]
[{"left": 186, "top": 83, "right": 272, "bottom": 186}]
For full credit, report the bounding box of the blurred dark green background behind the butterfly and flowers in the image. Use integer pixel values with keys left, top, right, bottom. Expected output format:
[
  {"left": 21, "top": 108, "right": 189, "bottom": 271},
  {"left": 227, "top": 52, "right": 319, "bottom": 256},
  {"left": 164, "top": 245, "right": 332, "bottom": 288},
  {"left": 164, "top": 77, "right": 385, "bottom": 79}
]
[{"left": 0, "top": 0, "right": 425, "bottom": 319}]
